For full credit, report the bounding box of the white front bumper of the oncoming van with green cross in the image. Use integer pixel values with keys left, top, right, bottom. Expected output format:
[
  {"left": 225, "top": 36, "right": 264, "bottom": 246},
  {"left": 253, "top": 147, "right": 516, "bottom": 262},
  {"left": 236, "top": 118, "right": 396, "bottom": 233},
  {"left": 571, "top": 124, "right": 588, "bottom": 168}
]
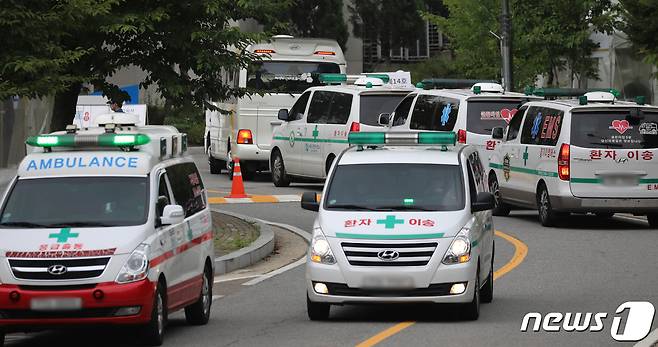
[{"left": 306, "top": 259, "right": 477, "bottom": 305}]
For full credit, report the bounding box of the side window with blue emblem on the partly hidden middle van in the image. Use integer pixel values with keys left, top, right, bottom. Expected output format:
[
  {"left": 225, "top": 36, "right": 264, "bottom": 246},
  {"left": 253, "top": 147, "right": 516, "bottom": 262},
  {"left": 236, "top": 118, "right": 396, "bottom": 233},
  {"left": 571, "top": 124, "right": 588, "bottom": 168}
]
[{"left": 409, "top": 95, "right": 459, "bottom": 131}]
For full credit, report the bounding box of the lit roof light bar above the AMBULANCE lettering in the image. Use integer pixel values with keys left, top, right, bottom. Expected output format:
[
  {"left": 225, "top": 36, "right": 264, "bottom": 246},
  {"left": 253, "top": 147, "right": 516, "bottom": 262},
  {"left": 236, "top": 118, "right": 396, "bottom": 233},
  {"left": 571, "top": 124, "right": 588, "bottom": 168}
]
[{"left": 25, "top": 133, "right": 151, "bottom": 148}]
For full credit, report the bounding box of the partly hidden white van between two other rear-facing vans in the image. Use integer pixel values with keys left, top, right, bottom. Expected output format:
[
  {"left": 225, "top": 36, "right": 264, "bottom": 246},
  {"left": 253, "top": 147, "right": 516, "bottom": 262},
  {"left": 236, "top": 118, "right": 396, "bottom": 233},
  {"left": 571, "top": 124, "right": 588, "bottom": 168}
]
[{"left": 391, "top": 82, "right": 540, "bottom": 167}]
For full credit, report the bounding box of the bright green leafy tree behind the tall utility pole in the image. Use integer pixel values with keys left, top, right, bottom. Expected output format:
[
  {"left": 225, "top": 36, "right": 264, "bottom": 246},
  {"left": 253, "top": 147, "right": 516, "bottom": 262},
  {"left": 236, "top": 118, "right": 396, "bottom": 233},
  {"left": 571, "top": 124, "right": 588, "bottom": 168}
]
[{"left": 424, "top": 0, "right": 614, "bottom": 89}]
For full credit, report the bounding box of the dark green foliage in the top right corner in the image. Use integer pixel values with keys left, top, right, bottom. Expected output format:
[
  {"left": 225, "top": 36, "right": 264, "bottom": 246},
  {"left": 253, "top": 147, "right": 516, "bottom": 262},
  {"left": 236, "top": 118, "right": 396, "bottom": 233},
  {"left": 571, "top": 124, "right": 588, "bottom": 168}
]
[{"left": 620, "top": 0, "right": 658, "bottom": 66}]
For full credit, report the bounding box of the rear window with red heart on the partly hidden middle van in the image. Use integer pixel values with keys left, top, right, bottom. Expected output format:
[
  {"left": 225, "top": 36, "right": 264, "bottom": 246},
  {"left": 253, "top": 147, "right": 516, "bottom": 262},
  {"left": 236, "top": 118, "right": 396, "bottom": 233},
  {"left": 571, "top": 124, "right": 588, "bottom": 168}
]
[{"left": 466, "top": 99, "right": 521, "bottom": 135}]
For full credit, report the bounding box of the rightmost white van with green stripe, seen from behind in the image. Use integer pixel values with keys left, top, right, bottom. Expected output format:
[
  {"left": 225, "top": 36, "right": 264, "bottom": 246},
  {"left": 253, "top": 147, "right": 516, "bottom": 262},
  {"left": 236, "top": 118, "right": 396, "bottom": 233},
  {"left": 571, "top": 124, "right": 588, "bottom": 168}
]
[{"left": 489, "top": 89, "right": 658, "bottom": 228}]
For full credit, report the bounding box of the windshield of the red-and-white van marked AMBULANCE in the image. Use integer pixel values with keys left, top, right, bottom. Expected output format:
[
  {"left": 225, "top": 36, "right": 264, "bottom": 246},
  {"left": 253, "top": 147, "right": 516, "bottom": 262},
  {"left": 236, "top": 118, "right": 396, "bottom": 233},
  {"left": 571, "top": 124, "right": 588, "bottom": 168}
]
[{"left": 0, "top": 177, "right": 148, "bottom": 228}]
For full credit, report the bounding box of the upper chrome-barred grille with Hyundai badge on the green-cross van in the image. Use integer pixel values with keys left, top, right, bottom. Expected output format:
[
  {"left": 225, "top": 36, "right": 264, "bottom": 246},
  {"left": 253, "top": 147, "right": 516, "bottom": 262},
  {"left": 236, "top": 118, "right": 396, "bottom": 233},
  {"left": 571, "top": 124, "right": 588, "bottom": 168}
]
[{"left": 341, "top": 242, "right": 438, "bottom": 266}]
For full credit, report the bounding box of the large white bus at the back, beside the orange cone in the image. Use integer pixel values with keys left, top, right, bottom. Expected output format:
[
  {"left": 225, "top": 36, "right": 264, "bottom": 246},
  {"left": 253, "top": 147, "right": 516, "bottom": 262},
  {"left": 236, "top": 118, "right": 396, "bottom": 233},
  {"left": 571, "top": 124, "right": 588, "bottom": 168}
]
[{"left": 205, "top": 35, "right": 346, "bottom": 179}]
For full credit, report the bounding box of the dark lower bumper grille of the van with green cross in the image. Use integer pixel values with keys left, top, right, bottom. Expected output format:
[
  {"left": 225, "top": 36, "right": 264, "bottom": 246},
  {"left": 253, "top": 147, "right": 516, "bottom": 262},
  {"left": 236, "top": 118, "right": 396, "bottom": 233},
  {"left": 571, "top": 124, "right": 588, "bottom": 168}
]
[{"left": 323, "top": 282, "right": 452, "bottom": 298}]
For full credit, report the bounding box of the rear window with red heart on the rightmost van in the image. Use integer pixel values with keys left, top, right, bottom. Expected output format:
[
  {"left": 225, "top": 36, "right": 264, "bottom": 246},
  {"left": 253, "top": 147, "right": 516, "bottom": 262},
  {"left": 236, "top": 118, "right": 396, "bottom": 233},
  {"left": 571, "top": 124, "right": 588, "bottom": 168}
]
[{"left": 571, "top": 108, "right": 658, "bottom": 149}]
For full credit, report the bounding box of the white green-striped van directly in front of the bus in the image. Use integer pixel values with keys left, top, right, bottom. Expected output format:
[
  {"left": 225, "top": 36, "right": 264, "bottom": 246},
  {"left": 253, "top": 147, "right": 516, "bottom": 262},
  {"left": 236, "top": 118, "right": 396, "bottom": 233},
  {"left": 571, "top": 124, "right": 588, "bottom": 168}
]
[{"left": 270, "top": 71, "right": 415, "bottom": 187}]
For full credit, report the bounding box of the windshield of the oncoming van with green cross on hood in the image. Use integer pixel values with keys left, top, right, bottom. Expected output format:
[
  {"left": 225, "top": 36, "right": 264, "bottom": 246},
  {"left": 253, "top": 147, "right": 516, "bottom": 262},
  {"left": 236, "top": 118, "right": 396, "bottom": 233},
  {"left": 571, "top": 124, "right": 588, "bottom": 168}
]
[{"left": 324, "top": 164, "right": 464, "bottom": 211}]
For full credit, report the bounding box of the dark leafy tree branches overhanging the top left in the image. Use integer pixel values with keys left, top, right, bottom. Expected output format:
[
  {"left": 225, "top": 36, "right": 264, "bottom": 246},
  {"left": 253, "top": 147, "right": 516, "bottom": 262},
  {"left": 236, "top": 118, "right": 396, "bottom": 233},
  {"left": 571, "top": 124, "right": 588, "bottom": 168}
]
[{"left": 0, "top": 0, "right": 290, "bottom": 129}]
